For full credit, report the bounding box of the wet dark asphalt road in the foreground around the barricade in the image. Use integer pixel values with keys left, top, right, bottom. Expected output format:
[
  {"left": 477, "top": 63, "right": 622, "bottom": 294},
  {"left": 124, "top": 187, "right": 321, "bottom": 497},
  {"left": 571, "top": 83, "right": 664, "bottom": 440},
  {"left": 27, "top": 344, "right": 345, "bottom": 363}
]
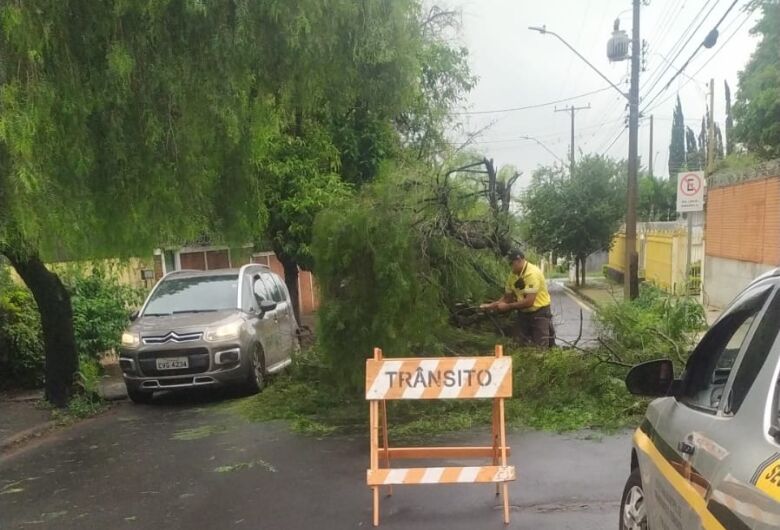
[{"left": 0, "top": 394, "right": 630, "bottom": 530}]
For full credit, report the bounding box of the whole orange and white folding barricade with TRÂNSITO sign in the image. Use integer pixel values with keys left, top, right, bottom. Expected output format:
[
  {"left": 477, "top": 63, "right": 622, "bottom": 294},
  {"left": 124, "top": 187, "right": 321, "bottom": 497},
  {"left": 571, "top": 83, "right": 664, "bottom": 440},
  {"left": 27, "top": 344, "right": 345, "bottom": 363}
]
[{"left": 366, "top": 346, "right": 515, "bottom": 526}]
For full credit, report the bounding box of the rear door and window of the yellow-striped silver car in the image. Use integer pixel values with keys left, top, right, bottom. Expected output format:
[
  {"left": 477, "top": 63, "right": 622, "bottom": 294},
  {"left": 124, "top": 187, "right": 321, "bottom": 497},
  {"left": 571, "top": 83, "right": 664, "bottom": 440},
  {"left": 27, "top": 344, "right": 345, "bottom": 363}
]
[{"left": 693, "top": 282, "right": 780, "bottom": 530}]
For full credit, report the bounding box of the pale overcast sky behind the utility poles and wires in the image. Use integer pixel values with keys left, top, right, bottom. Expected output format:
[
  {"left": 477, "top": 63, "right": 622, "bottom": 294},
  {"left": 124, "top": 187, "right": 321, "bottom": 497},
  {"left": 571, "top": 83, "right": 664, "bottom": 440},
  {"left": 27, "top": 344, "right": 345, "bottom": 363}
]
[{"left": 448, "top": 0, "right": 759, "bottom": 187}]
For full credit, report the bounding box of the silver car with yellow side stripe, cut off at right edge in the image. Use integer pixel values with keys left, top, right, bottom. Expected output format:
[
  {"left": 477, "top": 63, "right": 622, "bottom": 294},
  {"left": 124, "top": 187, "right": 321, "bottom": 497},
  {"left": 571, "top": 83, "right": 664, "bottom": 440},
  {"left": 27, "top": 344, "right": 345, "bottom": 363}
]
[{"left": 620, "top": 269, "right": 780, "bottom": 530}]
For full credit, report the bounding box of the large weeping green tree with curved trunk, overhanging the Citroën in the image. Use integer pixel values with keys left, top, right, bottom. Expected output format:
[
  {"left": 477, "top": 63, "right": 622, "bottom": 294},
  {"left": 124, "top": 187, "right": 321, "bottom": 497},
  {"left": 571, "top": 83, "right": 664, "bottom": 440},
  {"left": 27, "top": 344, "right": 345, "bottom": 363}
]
[{"left": 0, "top": 0, "right": 472, "bottom": 405}]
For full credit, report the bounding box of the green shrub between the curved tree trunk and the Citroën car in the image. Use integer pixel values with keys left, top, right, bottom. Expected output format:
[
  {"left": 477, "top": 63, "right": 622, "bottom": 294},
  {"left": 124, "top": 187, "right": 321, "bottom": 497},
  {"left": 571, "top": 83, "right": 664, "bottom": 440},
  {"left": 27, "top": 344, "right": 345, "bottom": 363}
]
[{"left": 63, "top": 267, "right": 142, "bottom": 359}]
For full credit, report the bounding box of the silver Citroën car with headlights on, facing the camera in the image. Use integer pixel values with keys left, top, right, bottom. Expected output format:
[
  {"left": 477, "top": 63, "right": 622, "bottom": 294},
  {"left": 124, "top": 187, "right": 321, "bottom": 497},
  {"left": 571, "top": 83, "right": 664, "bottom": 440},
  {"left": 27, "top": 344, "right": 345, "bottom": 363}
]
[{"left": 119, "top": 264, "right": 299, "bottom": 403}]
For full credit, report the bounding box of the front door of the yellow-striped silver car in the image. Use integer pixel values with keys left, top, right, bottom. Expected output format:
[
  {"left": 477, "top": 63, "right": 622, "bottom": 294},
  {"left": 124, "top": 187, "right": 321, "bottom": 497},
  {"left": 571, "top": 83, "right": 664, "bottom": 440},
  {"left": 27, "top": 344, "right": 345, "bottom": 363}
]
[{"left": 643, "top": 283, "right": 774, "bottom": 529}]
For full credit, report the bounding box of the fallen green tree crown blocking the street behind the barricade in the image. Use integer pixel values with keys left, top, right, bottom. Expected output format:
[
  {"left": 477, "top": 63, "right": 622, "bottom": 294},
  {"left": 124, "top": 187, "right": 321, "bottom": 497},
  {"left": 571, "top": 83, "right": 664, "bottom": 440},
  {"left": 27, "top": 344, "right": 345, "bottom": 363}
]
[{"left": 312, "top": 175, "right": 507, "bottom": 391}]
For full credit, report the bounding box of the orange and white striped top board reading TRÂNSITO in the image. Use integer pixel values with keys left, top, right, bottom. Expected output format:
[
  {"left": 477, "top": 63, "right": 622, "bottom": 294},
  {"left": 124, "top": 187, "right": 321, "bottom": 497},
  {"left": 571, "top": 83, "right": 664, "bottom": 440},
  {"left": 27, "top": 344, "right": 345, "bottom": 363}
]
[{"left": 366, "top": 357, "right": 512, "bottom": 400}]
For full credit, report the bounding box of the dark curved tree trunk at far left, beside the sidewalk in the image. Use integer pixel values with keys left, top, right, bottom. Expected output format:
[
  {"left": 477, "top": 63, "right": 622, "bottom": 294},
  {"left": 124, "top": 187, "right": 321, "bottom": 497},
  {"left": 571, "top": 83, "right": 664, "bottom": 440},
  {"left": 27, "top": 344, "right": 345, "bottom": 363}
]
[{"left": 2, "top": 248, "right": 78, "bottom": 407}]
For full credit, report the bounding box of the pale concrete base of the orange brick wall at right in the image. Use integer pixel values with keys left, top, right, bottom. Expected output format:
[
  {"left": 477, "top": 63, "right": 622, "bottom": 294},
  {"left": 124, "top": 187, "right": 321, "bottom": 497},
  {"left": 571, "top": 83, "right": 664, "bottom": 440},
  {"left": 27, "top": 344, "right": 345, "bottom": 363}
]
[{"left": 703, "top": 256, "right": 775, "bottom": 309}]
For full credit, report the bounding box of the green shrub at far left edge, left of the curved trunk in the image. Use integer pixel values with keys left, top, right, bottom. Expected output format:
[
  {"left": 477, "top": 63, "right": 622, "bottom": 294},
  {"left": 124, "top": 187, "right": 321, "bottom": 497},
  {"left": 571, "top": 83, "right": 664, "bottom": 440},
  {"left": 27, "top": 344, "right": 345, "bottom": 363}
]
[{"left": 0, "top": 272, "right": 44, "bottom": 388}]
